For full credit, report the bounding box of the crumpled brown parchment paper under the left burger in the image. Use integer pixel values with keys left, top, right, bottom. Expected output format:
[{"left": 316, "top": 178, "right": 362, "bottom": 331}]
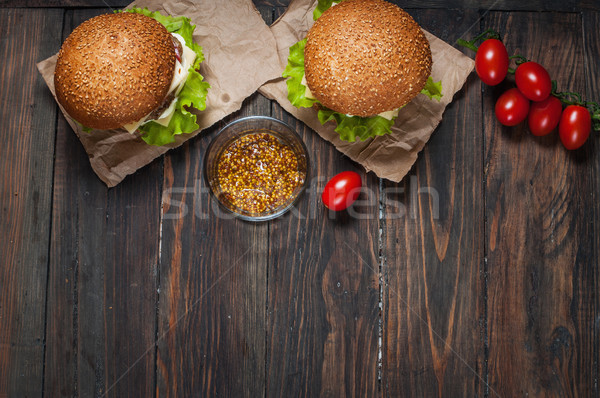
[{"left": 37, "top": 0, "right": 285, "bottom": 187}]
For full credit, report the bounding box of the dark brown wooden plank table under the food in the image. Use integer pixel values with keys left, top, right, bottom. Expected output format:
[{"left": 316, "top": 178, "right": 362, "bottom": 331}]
[{"left": 0, "top": 0, "right": 600, "bottom": 398}]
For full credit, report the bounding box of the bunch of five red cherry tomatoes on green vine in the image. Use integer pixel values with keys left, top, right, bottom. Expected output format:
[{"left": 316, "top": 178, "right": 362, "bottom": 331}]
[{"left": 457, "top": 29, "right": 600, "bottom": 149}]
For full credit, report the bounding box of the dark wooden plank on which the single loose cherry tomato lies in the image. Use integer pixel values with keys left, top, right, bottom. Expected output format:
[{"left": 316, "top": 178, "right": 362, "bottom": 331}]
[{"left": 266, "top": 105, "right": 379, "bottom": 397}]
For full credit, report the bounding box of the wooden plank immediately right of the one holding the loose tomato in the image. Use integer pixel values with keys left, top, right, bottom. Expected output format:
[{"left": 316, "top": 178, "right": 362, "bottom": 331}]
[{"left": 382, "top": 10, "right": 487, "bottom": 397}]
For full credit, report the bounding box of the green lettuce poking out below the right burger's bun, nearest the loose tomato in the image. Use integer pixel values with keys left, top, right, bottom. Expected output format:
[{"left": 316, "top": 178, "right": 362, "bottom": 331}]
[{"left": 317, "top": 108, "right": 396, "bottom": 142}]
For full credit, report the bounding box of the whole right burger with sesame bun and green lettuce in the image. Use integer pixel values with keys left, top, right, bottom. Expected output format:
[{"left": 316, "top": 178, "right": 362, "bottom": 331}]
[{"left": 283, "top": 0, "right": 442, "bottom": 142}]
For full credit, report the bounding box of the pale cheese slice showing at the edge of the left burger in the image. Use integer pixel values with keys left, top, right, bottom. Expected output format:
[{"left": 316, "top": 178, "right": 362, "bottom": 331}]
[{"left": 123, "top": 33, "right": 196, "bottom": 133}]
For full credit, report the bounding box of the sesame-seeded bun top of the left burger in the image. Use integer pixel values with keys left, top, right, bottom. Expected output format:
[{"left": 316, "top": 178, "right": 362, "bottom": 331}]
[{"left": 54, "top": 12, "right": 176, "bottom": 129}]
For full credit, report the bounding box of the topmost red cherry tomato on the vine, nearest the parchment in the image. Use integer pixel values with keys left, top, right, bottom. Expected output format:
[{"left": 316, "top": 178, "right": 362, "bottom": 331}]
[{"left": 475, "top": 39, "right": 508, "bottom": 86}]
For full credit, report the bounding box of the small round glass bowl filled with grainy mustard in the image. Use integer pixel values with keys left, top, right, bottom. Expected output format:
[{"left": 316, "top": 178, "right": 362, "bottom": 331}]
[{"left": 204, "top": 116, "right": 309, "bottom": 221}]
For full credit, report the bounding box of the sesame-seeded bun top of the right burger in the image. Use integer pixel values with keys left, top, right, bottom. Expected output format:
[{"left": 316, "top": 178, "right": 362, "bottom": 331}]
[{"left": 304, "top": 0, "right": 432, "bottom": 117}]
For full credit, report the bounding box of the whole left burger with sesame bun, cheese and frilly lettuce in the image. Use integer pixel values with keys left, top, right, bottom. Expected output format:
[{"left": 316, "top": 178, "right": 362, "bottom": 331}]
[{"left": 54, "top": 8, "right": 210, "bottom": 145}]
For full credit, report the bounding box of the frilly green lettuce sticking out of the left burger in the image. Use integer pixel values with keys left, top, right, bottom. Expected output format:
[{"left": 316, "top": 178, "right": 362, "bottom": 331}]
[{"left": 124, "top": 7, "right": 210, "bottom": 146}]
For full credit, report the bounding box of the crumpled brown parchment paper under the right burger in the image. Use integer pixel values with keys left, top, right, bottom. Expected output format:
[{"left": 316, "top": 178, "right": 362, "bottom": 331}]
[{"left": 259, "top": 0, "right": 474, "bottom": 182}]
